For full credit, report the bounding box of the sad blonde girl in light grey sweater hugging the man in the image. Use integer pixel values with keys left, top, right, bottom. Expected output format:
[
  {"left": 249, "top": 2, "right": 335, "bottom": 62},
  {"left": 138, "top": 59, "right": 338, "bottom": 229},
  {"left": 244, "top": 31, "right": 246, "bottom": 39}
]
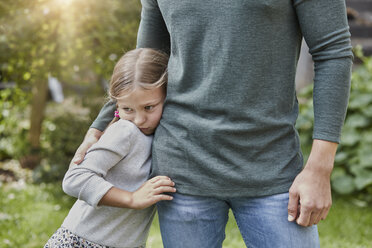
[{"left": 45, "top": 48, "right": 176, "bottom": 248}]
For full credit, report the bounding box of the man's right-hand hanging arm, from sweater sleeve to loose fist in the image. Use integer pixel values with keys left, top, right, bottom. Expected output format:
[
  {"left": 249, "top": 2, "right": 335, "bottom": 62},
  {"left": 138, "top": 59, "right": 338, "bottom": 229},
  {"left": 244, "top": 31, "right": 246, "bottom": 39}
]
[{"left": 288, "top": 0, "right": 353, "bottom": 226}]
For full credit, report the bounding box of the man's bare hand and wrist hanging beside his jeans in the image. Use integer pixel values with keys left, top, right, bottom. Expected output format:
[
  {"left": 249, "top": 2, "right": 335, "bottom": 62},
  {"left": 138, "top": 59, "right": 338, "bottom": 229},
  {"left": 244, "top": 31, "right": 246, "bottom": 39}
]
[{"left": 288, "top": 140, "right": 337, "bottom": 226}]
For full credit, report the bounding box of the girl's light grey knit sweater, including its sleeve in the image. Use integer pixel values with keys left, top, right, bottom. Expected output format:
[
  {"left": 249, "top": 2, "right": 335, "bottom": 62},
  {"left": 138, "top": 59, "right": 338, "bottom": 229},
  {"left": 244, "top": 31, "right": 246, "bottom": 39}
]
[{"left": 62, "top": 120, "right": 155, "bottom": 247}]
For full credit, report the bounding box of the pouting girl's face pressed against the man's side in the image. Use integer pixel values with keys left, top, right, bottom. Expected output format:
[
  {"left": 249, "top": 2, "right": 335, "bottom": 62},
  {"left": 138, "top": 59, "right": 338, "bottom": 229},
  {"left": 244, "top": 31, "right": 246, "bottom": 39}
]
[{"left": 117, "top": 87, "right": 165, "bottom": 135}]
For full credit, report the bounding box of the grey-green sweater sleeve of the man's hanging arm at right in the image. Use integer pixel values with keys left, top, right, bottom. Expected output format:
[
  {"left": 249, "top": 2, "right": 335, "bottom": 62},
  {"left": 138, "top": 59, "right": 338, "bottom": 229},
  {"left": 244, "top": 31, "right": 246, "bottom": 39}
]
[{"left": 294, "top": 0, "right": 353, "bottom": 143}]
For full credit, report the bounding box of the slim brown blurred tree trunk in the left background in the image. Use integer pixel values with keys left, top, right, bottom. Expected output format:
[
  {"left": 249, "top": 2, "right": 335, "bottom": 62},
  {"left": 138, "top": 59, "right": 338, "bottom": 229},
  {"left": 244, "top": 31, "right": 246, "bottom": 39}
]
[{"left": 21, "top": 79, "right": 48, "bottom": 169}]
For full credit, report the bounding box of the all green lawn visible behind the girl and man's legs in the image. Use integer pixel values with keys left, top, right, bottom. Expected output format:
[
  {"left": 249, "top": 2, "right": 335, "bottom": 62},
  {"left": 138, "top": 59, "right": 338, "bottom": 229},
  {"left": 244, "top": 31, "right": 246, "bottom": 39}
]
[{"left": 0, "top": 183, "right": 372, "bottom": 248}]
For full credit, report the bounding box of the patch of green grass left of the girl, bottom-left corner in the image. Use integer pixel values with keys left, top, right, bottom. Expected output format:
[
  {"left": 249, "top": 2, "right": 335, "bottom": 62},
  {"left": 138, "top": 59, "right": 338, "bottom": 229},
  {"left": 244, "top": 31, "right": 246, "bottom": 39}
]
[{"left": 0, "top": 181, "right": 73, "bottom": 248}]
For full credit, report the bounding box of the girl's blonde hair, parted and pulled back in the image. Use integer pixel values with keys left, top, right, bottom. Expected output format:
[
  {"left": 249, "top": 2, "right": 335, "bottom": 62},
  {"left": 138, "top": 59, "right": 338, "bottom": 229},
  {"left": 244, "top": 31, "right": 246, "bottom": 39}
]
[{"left": 108, "top": 48, "right": 169, "bottom": 125}]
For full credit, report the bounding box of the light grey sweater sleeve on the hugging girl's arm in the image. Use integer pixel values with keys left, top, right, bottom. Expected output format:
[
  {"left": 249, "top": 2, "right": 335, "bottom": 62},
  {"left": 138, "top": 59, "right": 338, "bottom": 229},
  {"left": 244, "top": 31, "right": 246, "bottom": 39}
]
[{"left": 62, "top": 120, "right": 135, "bottom": 207}]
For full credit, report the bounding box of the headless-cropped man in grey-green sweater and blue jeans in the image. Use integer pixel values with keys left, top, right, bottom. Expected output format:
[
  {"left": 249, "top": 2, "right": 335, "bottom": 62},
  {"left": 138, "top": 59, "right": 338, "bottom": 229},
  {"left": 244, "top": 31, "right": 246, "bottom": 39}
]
[{"left": 72, "top": 0, "right": 352, "bottom": 247}]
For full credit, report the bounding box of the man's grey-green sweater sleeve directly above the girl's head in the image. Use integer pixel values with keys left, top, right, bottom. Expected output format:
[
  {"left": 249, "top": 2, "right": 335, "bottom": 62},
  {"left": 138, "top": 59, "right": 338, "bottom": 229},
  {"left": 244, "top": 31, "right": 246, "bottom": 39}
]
[{"left": 137, "top": 0, "right": 170, "bottom": 53}]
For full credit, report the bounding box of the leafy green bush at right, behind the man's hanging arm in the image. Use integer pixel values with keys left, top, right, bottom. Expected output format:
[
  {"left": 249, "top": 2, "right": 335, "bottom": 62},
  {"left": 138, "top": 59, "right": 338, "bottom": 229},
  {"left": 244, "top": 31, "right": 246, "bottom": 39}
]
[{"left": 297, "top": 47, "right": 372, "bottom": 197}]
